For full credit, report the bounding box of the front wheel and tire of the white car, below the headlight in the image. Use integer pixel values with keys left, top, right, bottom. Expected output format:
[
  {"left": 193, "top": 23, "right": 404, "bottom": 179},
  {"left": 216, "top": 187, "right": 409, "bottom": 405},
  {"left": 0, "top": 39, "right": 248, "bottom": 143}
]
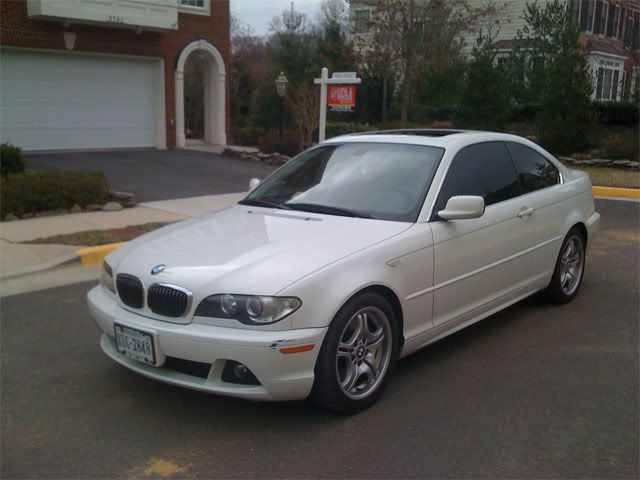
[{"left": 311, "top": 292, "right": 399, "bottom": 414}]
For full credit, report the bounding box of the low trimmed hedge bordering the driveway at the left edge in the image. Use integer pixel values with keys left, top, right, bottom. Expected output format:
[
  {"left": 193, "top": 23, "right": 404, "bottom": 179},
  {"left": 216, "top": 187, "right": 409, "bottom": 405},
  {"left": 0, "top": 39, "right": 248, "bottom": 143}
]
[{"left": 0, "top": 171, "right": 109, "bottom": 218}]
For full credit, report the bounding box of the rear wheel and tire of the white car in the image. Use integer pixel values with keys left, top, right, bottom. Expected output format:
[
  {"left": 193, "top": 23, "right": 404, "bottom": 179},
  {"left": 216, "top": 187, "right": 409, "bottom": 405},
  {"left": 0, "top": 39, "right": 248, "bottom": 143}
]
[{"left": 546, "top": 227, "right": 586, "bottom": 304}]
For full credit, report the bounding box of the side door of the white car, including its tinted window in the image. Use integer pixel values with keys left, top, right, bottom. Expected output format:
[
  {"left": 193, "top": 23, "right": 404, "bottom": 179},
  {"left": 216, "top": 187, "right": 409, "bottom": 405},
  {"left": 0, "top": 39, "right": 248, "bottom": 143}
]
[{"left": 430, "top": 142, "right": 536, "bottom": 327}]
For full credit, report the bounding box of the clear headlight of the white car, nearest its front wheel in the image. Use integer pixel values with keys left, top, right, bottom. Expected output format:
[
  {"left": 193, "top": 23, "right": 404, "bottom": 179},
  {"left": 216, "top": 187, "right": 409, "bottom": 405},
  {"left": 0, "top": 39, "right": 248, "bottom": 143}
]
[{"left": 195, "top": 293, "right": 302, "bottom": 325}]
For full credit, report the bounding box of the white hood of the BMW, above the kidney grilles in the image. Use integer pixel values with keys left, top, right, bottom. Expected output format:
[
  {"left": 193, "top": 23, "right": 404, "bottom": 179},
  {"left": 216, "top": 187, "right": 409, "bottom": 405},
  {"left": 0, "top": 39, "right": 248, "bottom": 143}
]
[{"left": 107, "top": 205, "right": 411, "bottom": 298}]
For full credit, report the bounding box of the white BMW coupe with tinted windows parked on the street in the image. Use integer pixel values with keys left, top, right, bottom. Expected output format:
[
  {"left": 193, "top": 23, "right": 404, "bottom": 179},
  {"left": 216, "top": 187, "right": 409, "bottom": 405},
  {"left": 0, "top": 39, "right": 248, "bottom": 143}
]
[{"left": 88, "top": 130, "right": 600, "bottom": 413}]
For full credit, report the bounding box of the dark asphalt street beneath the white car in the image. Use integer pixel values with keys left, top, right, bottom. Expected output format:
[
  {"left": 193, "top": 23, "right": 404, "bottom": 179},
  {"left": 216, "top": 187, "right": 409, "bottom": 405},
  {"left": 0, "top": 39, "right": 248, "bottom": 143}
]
[{"left": 0, "top": 198, "right": 640, "bottom": 478}]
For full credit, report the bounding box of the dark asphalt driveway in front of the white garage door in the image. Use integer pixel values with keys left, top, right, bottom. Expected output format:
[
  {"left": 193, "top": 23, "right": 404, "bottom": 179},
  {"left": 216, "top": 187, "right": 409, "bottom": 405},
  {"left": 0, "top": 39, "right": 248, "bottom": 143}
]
[{"left": 25, "top": 149, "right": 274, "bottom": 202}]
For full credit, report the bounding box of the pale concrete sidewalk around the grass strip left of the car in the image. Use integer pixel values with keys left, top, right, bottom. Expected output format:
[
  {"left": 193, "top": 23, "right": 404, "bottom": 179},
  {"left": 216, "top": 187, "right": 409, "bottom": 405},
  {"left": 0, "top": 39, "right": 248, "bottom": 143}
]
[{"left": 0, "top": 192, "right": 246, "bottom": 284}]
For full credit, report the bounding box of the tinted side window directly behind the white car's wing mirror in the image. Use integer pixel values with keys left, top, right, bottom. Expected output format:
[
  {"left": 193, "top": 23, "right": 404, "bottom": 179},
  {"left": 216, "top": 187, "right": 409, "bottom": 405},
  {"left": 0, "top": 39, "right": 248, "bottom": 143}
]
[{"left": 433, "top": 142, "right": 520, "bottom": 218}]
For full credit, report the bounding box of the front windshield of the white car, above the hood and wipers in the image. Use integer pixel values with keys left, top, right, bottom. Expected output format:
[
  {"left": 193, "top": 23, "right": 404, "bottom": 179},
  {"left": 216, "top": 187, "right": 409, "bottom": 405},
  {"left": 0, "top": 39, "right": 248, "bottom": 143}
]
[{"left": 240, "top": 143, "right": 444, "bottom": 222}]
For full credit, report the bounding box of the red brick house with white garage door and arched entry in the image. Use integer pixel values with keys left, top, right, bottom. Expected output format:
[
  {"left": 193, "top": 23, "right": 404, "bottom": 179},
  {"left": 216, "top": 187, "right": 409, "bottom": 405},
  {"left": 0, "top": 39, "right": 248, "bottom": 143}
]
[{"left": 0, "top": 0, "right": 231, "bottom": 150}]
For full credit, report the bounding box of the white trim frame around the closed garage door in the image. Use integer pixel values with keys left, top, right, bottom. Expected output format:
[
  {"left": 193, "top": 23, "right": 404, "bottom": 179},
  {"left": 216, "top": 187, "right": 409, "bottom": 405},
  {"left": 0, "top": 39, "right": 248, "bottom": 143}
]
[{"left": 0, "top": 45, "right": 167, "bottom": 151}]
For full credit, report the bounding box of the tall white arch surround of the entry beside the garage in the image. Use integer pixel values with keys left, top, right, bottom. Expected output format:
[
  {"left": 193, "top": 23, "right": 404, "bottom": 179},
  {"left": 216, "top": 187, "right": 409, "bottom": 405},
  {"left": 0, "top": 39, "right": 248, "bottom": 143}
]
[{"left": 175, "top": 40, "right": 227, "bottom": 148}]
